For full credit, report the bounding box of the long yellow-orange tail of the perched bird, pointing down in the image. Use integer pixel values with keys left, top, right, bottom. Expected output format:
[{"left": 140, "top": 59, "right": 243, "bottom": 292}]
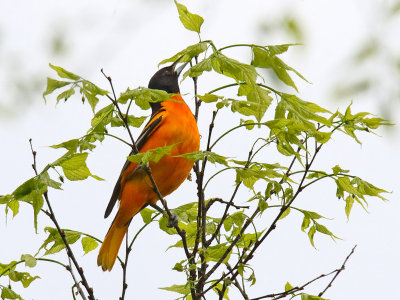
[{"left": 97, "top": 214, "right": 129, "bottom": 271}]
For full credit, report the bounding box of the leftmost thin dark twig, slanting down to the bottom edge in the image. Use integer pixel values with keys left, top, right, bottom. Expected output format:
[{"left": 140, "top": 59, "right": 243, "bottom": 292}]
[{"left": 29, "top": 139, "right": 95, "bottom": 300}]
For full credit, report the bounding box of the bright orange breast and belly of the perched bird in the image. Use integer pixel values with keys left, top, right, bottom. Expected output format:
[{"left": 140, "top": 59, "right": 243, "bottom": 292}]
[{"left": 120, "top": 95, "right": 200, "bottom": 214}]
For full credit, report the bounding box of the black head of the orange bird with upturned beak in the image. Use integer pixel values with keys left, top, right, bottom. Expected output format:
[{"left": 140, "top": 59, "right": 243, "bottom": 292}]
[{"left": 149, "top": 61, "right": 186, "bottom": 93}]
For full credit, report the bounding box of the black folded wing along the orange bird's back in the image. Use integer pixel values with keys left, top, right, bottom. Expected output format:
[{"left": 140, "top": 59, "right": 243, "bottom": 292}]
[{"left": 104, "top": 109, "right": 165, "bottom": 218}]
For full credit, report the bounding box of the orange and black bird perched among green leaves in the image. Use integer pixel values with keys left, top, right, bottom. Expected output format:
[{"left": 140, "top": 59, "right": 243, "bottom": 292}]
[{"left": 97, "top": 62, "right": 200, "bottom": 271}]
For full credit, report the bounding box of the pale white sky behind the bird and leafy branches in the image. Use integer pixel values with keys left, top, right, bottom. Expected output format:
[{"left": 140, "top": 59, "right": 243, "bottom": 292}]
[{"left": 0, "top": 0, "right": 400, "bottom": 300}]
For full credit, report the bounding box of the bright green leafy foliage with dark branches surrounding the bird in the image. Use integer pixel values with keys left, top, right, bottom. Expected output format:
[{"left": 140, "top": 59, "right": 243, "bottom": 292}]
[{"left": 0, "top": 1, "right": 388, "bottom": 299}]
